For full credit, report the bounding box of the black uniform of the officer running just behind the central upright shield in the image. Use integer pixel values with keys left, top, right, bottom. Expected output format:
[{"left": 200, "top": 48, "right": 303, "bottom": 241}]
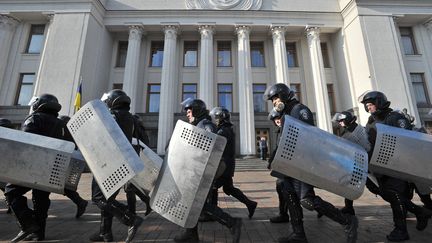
[{"left": 212, "top": 122, "right": 257, "bottom": 218}]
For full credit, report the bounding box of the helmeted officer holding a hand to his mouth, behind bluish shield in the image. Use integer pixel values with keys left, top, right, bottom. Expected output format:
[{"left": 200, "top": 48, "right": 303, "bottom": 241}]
[{"left": 264, "top": 83, "right": 358, "bottom": 242}]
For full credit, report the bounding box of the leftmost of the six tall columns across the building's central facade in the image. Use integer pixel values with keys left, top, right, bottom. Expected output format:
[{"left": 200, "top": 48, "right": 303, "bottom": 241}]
[{"left": 123, "top": 25, "right": 143, "bottom": 113}]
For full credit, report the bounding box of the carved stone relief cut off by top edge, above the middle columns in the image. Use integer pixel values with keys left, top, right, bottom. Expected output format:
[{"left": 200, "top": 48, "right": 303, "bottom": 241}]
[{"left": 185, "top": 0, "right": 262, "bottom": 10}]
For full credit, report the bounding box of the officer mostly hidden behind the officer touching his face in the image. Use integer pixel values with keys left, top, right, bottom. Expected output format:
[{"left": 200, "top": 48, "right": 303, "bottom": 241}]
[{"left": 268, "top": 109, "right": 290, "bottom": 224}]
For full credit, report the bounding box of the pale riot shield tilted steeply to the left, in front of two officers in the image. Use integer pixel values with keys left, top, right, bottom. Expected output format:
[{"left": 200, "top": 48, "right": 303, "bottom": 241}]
[{"left": 67, "top": 100, "right": 144, "bottom": 198}]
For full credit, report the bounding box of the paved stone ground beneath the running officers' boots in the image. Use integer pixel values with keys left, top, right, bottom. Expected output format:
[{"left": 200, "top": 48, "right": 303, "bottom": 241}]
[{"left": 0, "top": 159, "right": 432, "bottom": 243}]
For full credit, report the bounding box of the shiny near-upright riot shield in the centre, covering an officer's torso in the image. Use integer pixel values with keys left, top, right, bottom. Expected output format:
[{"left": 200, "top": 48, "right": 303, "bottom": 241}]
[{"left": 150, "top": 120, "right": 226, "bottom": 228}]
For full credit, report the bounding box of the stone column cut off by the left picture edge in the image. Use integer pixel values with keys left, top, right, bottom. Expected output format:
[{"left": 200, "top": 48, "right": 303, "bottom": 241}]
[{"left": 0, "top": 14, "right": 19, "bottom": 92}]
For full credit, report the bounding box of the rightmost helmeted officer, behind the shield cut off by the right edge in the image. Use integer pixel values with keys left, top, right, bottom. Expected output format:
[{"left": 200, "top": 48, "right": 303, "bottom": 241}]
[{"left": 359, "top": 91, "right": 430, "bottom": 241}]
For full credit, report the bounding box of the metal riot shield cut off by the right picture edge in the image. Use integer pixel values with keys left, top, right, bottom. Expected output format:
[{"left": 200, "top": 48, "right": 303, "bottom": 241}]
[{"left": 369, "top": 124, "right": 432, "bottom": 185}]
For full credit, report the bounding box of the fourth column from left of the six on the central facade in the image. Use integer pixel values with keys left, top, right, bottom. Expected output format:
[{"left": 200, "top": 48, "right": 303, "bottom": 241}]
[{"left": 236, "top": 26, "right": 255, "bottom": 155}]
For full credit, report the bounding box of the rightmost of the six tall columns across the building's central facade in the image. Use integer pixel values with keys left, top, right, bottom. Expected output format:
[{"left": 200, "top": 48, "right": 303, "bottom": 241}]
[{"left": 306, "top": 27, "right": 333, "bottom": 133}]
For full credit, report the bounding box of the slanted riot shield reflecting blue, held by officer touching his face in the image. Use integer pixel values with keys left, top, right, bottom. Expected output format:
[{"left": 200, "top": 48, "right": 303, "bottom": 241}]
[{"left": 272, "top": 116, "right": 368, "bottom": 200}]
